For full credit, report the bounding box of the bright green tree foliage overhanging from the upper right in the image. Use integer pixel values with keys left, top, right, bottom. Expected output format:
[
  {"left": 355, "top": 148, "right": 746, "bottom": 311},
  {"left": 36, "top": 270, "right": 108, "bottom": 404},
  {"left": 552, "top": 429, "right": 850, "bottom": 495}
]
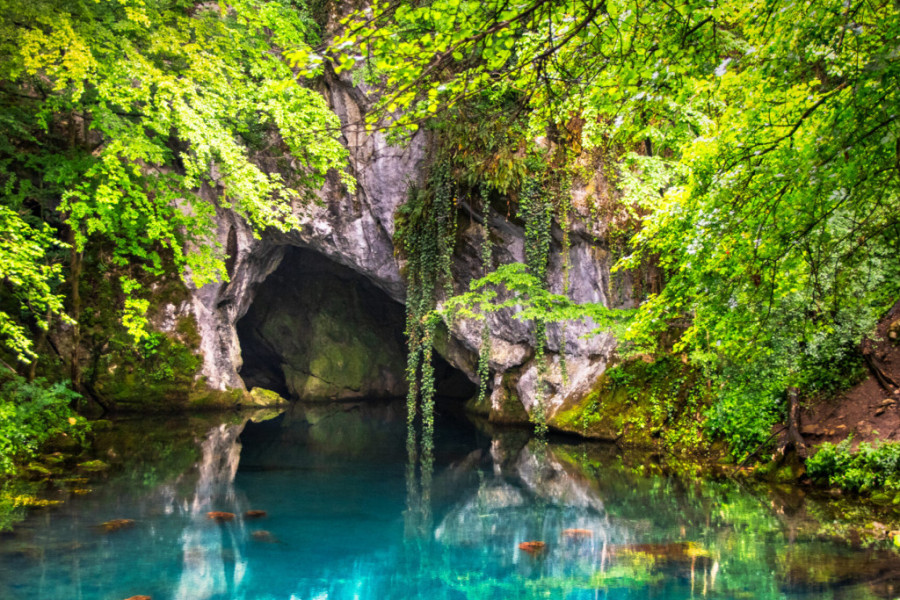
[{"left": 326, "top": 0, "right": 900, "bottom": 452}]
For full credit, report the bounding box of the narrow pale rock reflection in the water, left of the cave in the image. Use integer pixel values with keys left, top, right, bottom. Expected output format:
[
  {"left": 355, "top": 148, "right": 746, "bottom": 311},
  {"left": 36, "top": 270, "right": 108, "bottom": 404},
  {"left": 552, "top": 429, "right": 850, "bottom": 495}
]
[{"left": 175, "top": 423, "right": 247, "bottom": 600}]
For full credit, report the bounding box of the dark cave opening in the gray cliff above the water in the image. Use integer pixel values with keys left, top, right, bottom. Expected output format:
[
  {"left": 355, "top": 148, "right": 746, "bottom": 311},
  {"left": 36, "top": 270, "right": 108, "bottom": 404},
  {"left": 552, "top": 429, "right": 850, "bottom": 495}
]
[{"left": 237, "top": 248, "right": 477, "bottom": 401}]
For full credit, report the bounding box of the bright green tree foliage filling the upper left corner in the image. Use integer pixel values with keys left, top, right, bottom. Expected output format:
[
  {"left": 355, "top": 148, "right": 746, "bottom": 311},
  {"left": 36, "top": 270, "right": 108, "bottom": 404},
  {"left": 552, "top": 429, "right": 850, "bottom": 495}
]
[{"left": 0, "top": 0, "right": 352, "bottom": 361}]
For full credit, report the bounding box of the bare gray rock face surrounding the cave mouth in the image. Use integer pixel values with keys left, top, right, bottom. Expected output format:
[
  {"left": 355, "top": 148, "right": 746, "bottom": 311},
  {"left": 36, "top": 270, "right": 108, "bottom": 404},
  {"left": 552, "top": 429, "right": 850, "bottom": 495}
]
[{"left": 186, "top": 70, "right": 630, "bottom": 422}]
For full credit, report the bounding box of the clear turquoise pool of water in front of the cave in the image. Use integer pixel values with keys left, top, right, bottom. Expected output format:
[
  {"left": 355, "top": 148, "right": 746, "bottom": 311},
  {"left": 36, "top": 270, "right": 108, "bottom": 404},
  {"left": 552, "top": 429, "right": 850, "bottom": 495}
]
[{"left": 0, "top": 405, "right": 900, "bottom": 600}]
